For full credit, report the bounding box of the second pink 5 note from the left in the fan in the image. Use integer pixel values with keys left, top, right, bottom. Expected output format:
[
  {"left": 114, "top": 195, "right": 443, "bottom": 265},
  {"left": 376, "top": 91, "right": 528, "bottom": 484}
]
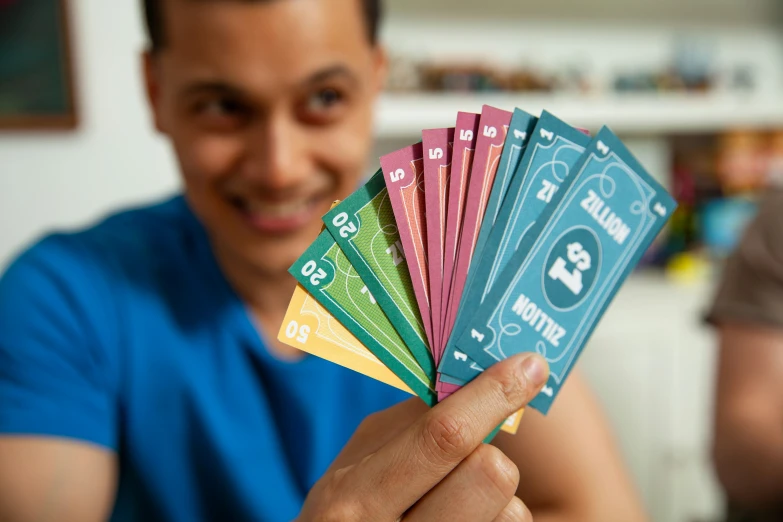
[{"left": 421, "top": 127, "right": 454, "bottom": 364}]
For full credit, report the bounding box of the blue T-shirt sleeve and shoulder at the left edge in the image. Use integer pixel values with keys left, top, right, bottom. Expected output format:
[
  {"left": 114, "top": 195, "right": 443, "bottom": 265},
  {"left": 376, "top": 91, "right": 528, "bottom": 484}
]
[{"left": 0, "top": 200, "right": 198, "bottom": 449}]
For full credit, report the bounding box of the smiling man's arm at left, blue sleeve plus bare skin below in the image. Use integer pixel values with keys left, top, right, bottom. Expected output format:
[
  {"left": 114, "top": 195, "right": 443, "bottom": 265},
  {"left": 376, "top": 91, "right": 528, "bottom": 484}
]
[{"left": 0, "top": 241, "right": 117, "bottom": 521}]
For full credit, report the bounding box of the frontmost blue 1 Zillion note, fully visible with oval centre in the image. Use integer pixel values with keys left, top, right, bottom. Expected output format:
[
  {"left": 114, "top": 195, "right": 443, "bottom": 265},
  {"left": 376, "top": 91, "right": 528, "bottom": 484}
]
[{"left": 457, "top": 128, "right": 676, "bottom": 413}]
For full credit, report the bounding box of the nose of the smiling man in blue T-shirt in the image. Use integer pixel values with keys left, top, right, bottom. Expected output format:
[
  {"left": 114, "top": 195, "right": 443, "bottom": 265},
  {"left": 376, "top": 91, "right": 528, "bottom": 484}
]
[{"left": 241, "top": 113, "right": 310, "bottom": 192}]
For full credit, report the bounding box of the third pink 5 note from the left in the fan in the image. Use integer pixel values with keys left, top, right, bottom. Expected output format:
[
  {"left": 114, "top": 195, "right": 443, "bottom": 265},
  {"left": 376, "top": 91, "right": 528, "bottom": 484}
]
[{"left": 438, "top": 112, "right": 480, "bottom": 355}]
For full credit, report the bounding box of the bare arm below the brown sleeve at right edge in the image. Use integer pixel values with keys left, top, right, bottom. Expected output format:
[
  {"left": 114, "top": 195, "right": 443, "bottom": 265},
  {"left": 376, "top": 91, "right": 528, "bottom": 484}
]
[{"left": 713, "top": 322, "right": 783, "bottom": 509}]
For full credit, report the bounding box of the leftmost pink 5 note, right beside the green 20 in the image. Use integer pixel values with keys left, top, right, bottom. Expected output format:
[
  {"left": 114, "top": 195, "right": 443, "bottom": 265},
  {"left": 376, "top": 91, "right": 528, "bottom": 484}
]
[{"left": 381, "top": 143, "right": 433, "bottom": 351}]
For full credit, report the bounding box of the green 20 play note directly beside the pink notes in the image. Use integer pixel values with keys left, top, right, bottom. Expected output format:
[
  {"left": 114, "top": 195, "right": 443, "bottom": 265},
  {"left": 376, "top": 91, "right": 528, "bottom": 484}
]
[{"left": 323, "top": 170, "right": 435, "bottom": 375}]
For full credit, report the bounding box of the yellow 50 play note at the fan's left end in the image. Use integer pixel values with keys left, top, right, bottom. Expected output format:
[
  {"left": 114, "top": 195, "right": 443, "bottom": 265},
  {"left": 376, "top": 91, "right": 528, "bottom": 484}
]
[{"left": 277, "top": 285, "right": 413, "bottom": 394}]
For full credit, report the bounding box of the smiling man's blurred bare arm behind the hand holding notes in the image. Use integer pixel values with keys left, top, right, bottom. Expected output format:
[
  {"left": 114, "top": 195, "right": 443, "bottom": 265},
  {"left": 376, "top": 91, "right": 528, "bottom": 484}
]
[{"left": 496, "top": 372, "right": 646, "bottom": 522}]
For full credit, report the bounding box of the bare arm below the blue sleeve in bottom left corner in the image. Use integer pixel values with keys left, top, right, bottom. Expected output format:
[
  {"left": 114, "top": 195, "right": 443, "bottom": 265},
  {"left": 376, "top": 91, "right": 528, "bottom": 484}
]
[{"left": 0, "top": 436, "right": 117, "bottom": 522}]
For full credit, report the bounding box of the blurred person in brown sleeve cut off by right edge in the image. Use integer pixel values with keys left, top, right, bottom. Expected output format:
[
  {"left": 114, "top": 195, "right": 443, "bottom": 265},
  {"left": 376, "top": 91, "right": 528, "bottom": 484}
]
[{"left": 709, "top": 190, "right": 783, "bottom": 522}]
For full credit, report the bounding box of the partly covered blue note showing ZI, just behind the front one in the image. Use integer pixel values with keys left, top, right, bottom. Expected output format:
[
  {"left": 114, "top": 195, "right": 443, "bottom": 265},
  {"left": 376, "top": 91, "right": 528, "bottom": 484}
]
[{"left": 439, "top": 112, "right": 590, "bottom": 381}]
